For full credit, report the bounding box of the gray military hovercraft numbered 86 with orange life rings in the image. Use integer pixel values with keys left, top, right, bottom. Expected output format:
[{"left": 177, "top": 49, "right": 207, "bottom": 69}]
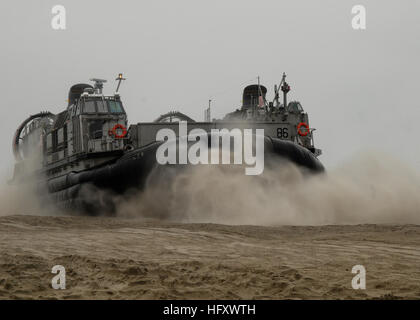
[{"left": 12, "top": 74, "right": 324, "bottom": 214}]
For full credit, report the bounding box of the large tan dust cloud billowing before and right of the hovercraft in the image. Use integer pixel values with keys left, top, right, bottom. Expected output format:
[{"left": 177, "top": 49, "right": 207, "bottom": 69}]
[{"left": 118, "top": 153, "right": 420, "bottom": 226}]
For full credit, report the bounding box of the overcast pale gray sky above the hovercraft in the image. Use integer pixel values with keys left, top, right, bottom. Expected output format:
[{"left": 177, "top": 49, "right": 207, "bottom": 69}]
[{"left": 0, "top": 0, "right": 420, "bottom": 175}]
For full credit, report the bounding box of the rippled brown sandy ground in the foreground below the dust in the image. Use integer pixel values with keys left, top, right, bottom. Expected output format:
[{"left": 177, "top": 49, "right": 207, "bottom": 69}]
[{"left": 0, "top": 216, "right": 420, "bottom": 299}]
